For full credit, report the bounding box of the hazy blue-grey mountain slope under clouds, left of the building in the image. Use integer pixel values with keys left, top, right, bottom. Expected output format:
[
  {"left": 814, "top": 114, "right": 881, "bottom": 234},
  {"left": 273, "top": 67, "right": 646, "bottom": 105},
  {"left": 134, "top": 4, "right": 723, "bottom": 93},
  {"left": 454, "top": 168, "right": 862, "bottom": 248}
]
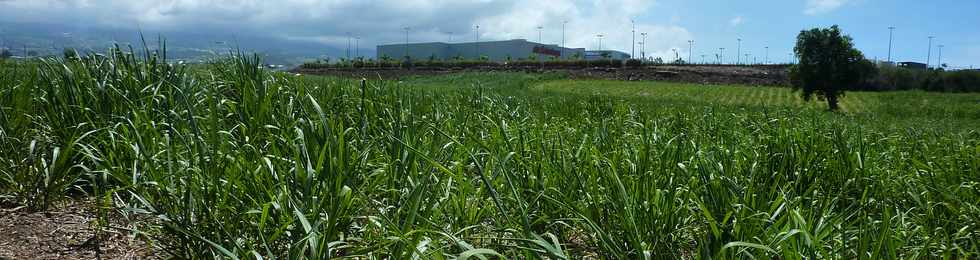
[{"left": 0, "top": 21, "right": 373, "bottom": 66}]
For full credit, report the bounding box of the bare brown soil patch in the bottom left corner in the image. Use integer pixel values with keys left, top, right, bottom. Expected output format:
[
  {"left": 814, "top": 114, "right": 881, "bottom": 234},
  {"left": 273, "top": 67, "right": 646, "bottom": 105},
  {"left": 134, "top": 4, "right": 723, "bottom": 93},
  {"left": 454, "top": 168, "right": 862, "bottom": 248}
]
[{"left": 0, "top": 200, "right": 157, "bottom": 259}]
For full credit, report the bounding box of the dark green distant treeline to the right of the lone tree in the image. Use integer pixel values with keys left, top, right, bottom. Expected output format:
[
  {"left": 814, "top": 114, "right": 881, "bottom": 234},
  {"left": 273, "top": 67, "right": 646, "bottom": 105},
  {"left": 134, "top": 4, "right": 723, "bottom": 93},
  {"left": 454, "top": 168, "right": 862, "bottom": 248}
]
[{"left": 852, "top": 65, "right": 980, "bottom": 92}]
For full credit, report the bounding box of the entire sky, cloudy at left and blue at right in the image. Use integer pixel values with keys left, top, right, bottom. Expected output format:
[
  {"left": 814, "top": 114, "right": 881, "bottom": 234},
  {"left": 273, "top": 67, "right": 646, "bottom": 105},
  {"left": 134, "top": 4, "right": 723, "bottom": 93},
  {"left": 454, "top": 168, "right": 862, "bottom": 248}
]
[{"left": 0, "top": 0, "right": 980, "bottom": 67}]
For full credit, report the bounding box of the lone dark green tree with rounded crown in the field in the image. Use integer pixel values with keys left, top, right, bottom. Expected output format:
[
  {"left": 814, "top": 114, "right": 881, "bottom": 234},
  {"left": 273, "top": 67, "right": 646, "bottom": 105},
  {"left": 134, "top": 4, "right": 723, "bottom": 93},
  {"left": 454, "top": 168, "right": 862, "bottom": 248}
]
[{"left": 790, "top": 25, "right": 876, "bottom": 111}]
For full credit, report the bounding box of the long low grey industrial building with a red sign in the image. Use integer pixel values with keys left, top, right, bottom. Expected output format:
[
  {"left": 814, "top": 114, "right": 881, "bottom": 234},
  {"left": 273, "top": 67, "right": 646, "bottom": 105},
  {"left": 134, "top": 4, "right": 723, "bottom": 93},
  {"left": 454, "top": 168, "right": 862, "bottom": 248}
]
[{"left": 377, "top": 39, "right": 629, "bottom": 62}]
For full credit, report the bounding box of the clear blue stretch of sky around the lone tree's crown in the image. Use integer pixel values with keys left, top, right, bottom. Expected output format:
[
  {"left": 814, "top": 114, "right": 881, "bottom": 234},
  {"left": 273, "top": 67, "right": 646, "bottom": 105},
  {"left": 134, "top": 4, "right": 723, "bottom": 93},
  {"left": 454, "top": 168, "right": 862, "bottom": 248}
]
[{"left": 639, "top": 0, "right": 980, "bottom": 66}]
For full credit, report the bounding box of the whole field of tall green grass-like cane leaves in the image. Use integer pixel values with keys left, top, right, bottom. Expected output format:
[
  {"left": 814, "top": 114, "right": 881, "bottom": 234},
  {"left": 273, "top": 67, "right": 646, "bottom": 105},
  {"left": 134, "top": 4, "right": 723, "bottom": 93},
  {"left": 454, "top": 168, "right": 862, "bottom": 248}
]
[{"left": 0, "top": 49, "right": 980, "bottom": 259}]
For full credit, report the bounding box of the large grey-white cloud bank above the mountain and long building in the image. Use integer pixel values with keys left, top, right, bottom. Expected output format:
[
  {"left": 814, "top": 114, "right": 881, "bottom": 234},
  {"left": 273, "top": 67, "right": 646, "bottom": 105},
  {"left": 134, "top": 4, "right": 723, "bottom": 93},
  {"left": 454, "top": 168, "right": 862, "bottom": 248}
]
[{"left": 0, "top": 0, "right": 692, "bottom": 54}]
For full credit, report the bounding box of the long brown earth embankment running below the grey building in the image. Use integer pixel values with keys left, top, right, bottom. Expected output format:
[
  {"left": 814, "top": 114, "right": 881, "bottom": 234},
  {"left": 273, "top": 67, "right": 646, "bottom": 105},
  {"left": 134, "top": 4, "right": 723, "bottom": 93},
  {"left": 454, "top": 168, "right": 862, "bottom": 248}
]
[{"left": 292, "top": 65, "right": 789, "bottom": 86}]
